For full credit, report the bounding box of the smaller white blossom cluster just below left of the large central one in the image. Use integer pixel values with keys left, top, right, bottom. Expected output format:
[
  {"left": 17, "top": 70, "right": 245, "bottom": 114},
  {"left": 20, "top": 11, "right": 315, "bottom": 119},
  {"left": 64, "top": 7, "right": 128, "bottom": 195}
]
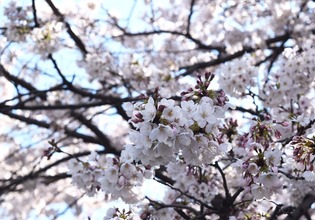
[{"left": 69, "top": 152, "right": 152, "bottom": 203}]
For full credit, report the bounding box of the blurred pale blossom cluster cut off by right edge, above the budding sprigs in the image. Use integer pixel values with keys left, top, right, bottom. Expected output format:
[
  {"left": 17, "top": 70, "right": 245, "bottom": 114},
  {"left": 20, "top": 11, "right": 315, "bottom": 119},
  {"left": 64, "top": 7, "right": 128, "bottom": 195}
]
[{"left": 261, "top": 45, "right": 315, "bottom": 110}]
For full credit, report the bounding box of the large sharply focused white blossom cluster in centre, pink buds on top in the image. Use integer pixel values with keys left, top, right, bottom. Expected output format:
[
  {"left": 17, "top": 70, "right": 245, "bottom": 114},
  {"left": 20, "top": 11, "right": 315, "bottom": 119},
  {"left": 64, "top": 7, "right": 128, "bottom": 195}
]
[{"left": 122, "top": 73, "right": 230, "bottom": 166}]
